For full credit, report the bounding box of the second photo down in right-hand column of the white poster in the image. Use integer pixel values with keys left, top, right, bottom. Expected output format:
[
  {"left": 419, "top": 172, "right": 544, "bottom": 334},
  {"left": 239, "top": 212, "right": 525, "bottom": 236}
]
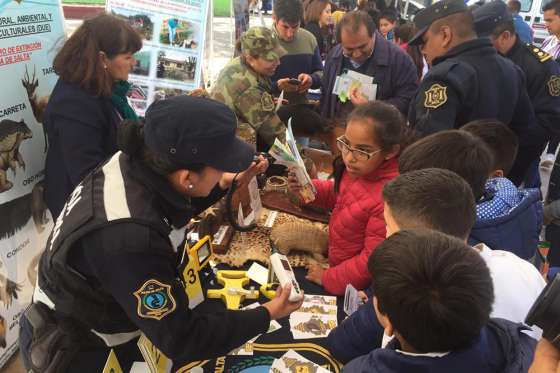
[{"left": 156, "top": 50, "right": 197, "bottom": 82}]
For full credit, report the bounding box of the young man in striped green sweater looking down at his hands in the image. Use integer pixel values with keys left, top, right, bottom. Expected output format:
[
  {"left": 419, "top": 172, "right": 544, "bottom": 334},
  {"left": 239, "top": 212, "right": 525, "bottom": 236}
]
[{"left": 271, "top": 0, "right": 326, "bottom": 136}]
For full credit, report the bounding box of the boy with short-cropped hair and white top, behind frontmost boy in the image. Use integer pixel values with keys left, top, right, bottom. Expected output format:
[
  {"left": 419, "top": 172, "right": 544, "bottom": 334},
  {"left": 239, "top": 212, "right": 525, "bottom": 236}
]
[{"left": 327, "top": 168, "right": 545, "bottom": 363}]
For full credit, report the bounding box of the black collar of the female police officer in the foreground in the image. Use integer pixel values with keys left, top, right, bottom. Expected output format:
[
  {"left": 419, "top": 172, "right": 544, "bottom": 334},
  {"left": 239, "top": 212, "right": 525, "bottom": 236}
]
[{"left": 130, "top": 159, "right": 193, "bottom": 228}]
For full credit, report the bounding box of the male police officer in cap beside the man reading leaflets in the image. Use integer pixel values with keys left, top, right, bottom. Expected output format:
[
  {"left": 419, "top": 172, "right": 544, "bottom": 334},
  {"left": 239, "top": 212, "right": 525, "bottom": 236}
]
[{"left": 409, "top": 0, "right": 535, "bottom": 157}]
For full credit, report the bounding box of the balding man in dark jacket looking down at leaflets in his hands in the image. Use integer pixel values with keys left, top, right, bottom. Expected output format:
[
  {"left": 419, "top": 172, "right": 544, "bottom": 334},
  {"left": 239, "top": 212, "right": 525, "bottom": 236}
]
[{"left": 321, "top": 11, "right": 418, "bottom": 123}]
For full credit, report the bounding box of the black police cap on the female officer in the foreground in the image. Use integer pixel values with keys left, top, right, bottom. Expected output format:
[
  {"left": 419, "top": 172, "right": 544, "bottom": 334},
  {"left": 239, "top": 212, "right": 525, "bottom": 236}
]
[{"left": 144, "top": 95, "right": 254, "bottom": 172}]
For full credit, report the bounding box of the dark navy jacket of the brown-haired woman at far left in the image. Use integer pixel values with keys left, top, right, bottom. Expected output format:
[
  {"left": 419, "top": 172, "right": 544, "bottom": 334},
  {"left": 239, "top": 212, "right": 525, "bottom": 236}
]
[{"left": 43, "top": 79, "right": 119, "bottom": 218}]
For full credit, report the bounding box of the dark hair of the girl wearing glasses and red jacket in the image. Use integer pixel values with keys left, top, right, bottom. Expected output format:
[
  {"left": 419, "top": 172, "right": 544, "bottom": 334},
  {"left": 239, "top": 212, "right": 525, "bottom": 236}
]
[{"left": 333, "top": 101, "right": 406, "bottom": 192}]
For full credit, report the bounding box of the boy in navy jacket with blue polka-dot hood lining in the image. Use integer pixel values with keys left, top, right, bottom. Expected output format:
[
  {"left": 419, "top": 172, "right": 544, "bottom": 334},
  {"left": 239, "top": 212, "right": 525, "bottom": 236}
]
[{"left": 461, "top": 119, "right": 543, "bottom": 260}]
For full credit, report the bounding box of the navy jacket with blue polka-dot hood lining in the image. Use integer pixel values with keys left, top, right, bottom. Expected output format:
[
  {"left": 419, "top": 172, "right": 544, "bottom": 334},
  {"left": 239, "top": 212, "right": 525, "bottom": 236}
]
[{"left": 469, "top": 178, "right": 543, "bottom": 259}]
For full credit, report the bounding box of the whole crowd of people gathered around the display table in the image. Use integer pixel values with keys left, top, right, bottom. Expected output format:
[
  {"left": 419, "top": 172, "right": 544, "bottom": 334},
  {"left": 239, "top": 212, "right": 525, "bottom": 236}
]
[{"left": 15, "top": 0, "right": 560, "bottom": 373}]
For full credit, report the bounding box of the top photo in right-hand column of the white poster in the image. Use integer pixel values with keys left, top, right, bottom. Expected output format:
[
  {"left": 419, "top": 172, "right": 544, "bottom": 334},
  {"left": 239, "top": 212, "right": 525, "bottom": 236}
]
[{"left": 159, "top": 17, "right": 200, "bottom": 49}]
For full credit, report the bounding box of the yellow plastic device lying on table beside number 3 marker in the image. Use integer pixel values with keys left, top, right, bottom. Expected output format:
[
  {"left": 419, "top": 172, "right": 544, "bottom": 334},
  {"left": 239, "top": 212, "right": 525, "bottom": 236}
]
[{"left": 207, "top": 270, "right": 259, "bottom": 310}]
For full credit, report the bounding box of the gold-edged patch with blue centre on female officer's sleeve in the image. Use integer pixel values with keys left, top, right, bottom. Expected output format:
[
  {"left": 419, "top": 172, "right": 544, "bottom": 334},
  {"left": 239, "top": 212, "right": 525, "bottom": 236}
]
[{"left": 134, "top": 279, "right": 177, "bottom": 320}]
